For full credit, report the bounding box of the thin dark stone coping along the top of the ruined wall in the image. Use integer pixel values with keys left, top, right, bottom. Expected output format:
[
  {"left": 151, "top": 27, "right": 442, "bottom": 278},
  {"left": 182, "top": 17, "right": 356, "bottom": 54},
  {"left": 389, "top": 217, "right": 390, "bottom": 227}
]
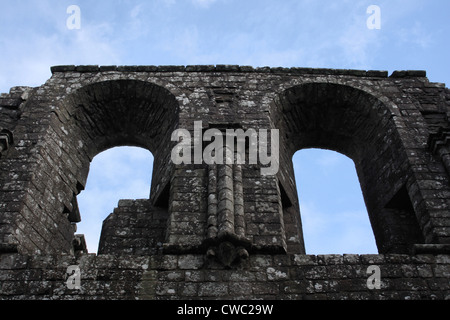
[{"left": 51, "top": 64, "right": 426, "bottom": 78}]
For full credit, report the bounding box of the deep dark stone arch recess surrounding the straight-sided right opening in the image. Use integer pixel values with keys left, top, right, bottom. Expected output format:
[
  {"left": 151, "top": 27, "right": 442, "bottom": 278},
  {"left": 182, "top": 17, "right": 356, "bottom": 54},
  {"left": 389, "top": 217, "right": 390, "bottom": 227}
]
[{"left": 272, "top": 83, "right": 424, "bottom": 253}]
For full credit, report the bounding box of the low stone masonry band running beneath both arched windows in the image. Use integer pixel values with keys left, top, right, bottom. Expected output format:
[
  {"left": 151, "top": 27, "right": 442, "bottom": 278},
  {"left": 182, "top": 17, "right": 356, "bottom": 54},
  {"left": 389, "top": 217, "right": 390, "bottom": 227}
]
[{"left": 0, "top": 254, "right": 450, "bottom": 300}]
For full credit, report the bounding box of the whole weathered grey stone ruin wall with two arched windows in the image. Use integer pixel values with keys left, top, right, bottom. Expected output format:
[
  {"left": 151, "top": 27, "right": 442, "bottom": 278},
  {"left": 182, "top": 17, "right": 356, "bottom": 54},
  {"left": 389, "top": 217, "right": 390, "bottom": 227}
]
[{"left": 0, "top": 65, "right": 450, "bottom": 300}]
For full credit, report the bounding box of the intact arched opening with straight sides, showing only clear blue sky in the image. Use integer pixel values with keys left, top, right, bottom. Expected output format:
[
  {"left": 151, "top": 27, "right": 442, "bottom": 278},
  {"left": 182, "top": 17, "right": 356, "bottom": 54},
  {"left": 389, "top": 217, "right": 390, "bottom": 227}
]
[{"left": 293, "top": 149, "right": 378, "bottom": 254}]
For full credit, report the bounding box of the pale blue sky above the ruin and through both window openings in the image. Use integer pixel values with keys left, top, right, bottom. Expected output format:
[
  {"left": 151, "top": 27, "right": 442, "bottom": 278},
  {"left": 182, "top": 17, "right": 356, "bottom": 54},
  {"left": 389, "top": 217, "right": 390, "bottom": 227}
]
[{"left": 0, "top": 0, "right": 450, "bottom": 254}]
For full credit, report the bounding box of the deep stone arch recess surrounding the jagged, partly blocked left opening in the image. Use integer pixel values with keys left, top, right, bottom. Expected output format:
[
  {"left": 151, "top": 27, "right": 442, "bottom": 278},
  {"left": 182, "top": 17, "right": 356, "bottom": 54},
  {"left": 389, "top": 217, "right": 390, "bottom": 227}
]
[{"left": 12, "top": 80, "right": 179, "bottom": 253}]
